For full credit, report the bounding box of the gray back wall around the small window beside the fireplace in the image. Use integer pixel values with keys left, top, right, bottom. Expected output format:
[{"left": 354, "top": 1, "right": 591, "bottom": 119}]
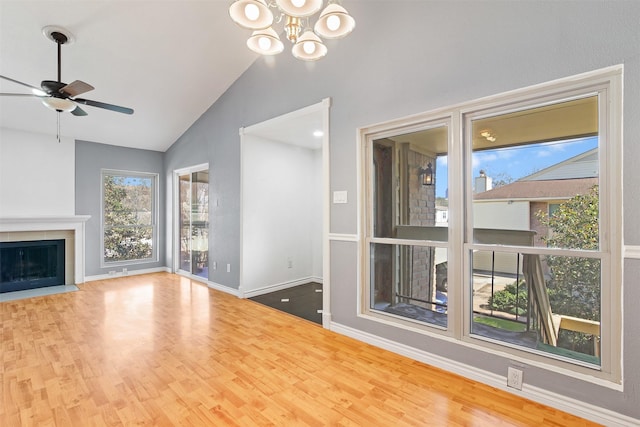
[{"left": 76, "top": 141, "right": 167, "bottom": 276}]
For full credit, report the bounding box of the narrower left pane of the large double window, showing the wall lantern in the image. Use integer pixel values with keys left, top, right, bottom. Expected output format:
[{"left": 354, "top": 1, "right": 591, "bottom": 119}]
[{"left": 366, "top": 119, "right": 450, "bottom": 328}]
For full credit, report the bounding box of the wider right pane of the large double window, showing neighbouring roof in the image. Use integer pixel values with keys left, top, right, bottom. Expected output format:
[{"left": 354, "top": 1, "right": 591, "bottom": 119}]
[{"left": 466, "top": 98, "right": 607, "bottom": 367}]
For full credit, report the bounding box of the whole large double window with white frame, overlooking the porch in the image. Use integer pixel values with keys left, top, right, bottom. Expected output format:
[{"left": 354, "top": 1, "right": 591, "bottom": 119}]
[{"left": 360, "top": 67, "right": 622, "bottom": 382}]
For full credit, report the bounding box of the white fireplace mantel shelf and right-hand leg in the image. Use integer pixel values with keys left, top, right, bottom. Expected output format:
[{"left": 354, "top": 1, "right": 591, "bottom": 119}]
[{"left": 0, "top": 215, "right": 91, "bottom": 284}]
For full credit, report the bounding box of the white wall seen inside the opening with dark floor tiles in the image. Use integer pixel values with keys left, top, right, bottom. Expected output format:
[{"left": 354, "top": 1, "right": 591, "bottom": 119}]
[{"left": 240, "top": 135, "right": 322, "bottom": 293}]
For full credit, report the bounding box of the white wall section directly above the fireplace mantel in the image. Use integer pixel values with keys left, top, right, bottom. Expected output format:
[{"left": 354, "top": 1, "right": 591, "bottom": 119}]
[{"left": 0, "top": 128, "right": 75, "bottom": 214}]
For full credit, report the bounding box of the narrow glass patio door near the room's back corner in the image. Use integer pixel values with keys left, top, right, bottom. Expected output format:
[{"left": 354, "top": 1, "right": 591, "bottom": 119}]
[{"left": 175, "top": 165, "right": 209, "bottom": 279}]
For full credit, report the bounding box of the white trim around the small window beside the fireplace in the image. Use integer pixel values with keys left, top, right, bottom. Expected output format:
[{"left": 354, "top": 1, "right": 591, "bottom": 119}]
[{"left": 100, "top": 169, "right": 160, "bottom": 268}]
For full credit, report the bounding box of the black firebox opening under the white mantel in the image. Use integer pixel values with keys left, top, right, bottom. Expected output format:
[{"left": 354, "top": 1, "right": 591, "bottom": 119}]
[{"left": 0, "top": 239, "right": 65, "bottom": 293}]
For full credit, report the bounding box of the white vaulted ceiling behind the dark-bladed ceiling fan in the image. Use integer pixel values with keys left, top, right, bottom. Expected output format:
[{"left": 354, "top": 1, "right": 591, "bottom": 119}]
[{"left": 0, "top": 0, "right": 256, "bottom": 151}]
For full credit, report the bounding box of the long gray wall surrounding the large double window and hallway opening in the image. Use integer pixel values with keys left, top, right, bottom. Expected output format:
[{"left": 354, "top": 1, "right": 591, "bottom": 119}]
[{"left": 165, "top": 0, "right": 640, "bottom": 418}]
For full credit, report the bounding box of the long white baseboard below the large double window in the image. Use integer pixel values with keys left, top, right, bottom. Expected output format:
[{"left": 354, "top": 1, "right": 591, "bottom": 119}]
[{"left": 332, "top": 319, "right": 640, "bottom": 427}]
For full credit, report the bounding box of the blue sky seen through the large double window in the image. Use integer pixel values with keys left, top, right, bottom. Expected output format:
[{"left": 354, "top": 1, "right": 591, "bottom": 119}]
[{"left": 436, "top": 137, "right": 598, "bottom": 197}]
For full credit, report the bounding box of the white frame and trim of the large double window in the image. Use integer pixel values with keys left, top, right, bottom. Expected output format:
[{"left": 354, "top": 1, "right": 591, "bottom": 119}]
[{"left": 357, "top": 65, "right": 623, "bottom": 390}]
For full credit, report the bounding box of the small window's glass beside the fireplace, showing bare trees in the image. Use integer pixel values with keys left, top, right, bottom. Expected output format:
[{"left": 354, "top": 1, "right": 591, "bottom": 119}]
[{"left": 102, "top": 170, "right": 158, "bottom": 266}]
